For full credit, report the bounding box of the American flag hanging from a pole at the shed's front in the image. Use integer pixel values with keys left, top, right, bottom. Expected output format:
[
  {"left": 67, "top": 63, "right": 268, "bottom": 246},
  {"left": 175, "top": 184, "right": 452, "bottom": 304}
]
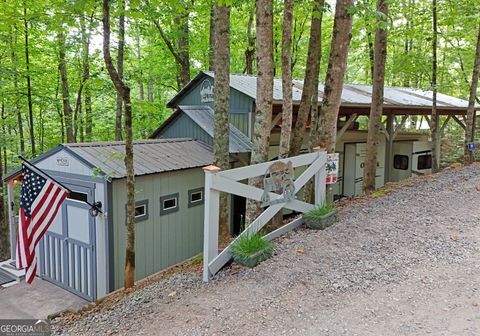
[{"left": 16, "top": 164, "right": 68, "bottom": 284}]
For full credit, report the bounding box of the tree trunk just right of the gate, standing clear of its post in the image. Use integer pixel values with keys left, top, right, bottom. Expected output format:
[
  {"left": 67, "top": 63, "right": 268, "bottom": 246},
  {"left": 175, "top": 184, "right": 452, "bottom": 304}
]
[{"left": 363, "top": 0, "right": 393, "bottom": 194}]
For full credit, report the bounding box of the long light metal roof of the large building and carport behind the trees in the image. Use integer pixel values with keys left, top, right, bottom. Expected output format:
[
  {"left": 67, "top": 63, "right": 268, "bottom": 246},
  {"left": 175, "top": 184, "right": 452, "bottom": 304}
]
[{"left": 167, "top": 71, "right": 480, "bottom": 110}]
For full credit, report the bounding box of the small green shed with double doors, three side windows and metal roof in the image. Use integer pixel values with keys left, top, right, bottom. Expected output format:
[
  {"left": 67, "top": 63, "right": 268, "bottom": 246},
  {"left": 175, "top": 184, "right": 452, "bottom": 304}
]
[{"left": 5, "top": 138, "right": 213, "bottom": 300}]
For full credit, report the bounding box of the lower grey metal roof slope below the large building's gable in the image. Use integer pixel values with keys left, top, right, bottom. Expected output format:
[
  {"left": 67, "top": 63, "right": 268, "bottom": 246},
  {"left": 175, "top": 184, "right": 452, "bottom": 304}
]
[{"left": 178, "top": 105, "right": 252, "bottom": 153}]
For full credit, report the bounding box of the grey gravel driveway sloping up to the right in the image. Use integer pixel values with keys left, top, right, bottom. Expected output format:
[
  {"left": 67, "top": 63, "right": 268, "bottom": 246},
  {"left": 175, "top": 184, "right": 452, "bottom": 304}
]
[{"left": 54, "top": 164, "right": 480, "bottom": 336}]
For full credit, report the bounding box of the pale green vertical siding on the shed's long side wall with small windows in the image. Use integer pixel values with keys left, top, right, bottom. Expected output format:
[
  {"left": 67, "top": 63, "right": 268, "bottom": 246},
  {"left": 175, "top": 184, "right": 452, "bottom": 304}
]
[{"left": 112, "top": 168, "right": 204, "bottom": 289}]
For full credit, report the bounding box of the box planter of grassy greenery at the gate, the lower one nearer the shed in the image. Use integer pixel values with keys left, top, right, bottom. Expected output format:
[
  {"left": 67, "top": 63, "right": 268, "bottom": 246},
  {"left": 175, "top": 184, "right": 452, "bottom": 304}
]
[{"left": 230, "top": 233, "right": 274, "bottom": 268}]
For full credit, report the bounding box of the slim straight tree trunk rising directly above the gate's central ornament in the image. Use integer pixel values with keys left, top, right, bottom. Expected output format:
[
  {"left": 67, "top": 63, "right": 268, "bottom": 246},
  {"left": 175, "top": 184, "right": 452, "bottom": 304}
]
[{"left": 279, "top": 0, "right": 293, "bottom": 157}]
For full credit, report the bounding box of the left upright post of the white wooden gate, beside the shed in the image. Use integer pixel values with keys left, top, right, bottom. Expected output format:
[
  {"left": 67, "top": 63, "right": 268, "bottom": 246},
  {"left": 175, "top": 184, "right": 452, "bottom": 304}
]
[{"left": 203, "top": 166, "right": 221, "bottom": 282}]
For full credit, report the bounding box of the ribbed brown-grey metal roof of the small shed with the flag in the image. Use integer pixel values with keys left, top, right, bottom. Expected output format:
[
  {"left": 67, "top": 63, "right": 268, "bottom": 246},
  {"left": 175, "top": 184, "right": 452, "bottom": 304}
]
[{"left": 62, "top": 138, "right": 213, "bottom": 178}]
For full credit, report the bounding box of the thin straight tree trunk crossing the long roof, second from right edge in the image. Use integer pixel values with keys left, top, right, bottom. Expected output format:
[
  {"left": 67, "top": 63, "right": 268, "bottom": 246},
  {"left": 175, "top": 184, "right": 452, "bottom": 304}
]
[{"left": 430, "top": 0, "right": 440, "bottom": 172}]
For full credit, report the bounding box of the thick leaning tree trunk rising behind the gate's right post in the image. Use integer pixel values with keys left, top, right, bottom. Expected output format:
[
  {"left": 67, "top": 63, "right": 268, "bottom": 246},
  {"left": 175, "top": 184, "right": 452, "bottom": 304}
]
[{"left": 319, "top": 0, "right": 354, "bottom": 201}]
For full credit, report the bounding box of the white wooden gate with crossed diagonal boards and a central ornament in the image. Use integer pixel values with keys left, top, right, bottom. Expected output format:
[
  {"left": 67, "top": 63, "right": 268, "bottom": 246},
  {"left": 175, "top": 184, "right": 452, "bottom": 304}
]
[{"left": 203, "top": 148, "right": 327, "bottom": 282}]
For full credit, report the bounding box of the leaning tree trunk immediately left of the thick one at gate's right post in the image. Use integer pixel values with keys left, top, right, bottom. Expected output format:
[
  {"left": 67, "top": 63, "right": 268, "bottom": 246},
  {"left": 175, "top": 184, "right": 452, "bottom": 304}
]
[{"left": 290, "top": 0, "right": 324, "bottom": 156}]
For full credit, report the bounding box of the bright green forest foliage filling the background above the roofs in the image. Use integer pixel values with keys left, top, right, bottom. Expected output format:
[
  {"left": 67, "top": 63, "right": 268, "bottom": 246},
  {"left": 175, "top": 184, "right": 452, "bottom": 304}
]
[{"left": 0, "top": 0, "right": 480, "bottom": 170}]
